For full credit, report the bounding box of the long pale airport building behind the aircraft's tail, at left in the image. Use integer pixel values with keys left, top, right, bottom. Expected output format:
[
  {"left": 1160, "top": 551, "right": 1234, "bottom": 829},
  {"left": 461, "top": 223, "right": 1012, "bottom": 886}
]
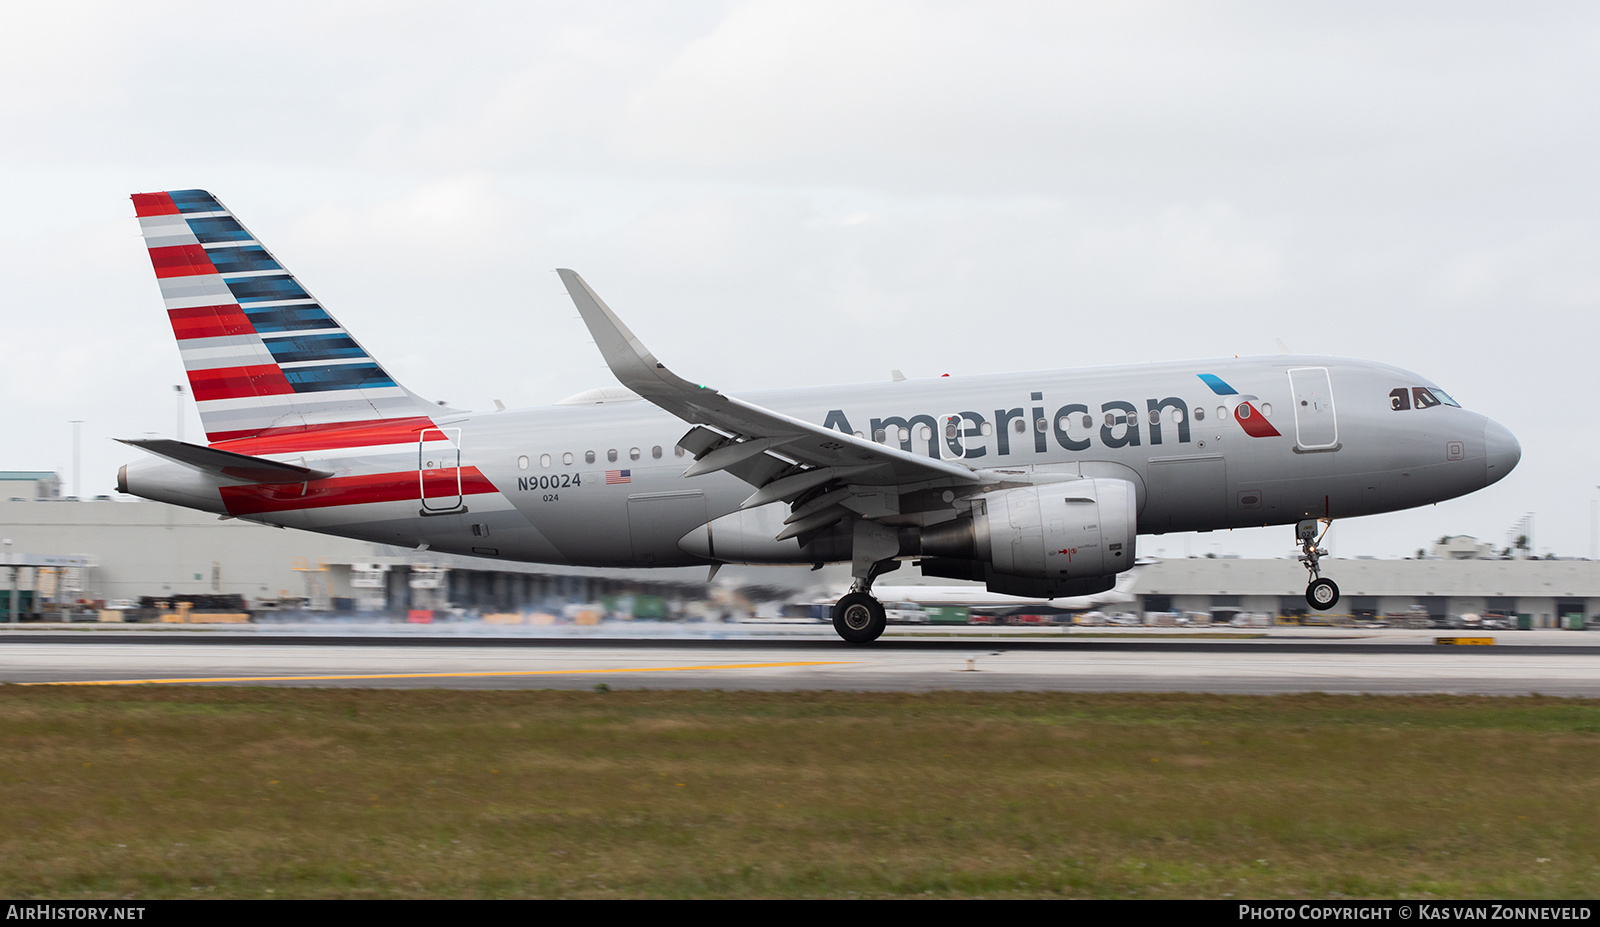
[{"left": 0, "top": 496, "right": 755, "bottom": 620}]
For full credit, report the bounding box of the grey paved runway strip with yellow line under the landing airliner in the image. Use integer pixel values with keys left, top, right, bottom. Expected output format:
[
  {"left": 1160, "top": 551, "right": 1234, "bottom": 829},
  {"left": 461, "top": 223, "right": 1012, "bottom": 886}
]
[{"left": 0, "top": 628, "right": 1600, "bottom": 698}]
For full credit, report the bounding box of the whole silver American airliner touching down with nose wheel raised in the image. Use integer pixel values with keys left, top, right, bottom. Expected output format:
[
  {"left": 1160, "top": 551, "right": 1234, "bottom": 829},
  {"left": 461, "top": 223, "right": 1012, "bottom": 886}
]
[{"left": 117, "top": 191, "right": 1522, "bottom": 644}]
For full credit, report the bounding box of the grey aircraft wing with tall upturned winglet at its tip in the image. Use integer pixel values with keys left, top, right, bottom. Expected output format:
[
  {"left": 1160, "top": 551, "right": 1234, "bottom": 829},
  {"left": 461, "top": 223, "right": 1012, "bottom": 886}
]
[{"left": 557, "top": 269, "right": 981, "bottom": 508}]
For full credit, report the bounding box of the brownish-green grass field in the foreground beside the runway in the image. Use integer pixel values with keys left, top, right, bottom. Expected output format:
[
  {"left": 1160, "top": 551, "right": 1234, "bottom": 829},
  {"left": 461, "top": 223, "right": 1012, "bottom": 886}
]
[{"left": 0, "top": 687, "right": 1600, "bottom": 898}]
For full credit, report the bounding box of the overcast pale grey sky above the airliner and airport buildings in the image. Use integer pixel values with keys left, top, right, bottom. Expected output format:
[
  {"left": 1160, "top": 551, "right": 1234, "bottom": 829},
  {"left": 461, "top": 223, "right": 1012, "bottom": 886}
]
[{"left": 0, "top": 0, "right": 1600, "bottom": 556}]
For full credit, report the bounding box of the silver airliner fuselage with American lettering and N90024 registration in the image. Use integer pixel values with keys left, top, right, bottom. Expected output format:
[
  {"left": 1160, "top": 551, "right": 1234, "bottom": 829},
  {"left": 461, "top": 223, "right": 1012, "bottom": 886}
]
[{"left": 123, "top": 357, "right": 1520, "bottom": 567}]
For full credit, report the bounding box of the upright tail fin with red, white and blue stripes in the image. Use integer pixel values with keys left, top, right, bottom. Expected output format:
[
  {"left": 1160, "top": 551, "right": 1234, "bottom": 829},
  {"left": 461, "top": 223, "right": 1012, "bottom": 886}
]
[{"left": 133, "top": 191, "right": 438, "bottom": 443}]
